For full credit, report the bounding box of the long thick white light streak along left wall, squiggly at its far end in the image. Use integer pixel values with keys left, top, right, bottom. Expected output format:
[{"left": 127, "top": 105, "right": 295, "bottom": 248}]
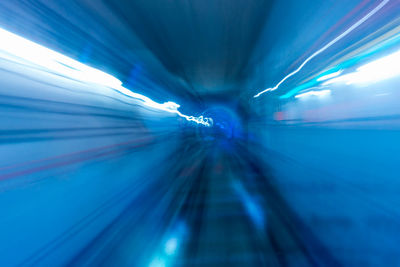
[{"left": 0, "top": 28, "right": 213, "bottom": 127}]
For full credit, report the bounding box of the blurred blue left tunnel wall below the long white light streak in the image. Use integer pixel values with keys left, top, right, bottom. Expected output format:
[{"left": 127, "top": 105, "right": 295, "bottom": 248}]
[{"left": 0, "top": 58, "right": 182, "bottom": 266}]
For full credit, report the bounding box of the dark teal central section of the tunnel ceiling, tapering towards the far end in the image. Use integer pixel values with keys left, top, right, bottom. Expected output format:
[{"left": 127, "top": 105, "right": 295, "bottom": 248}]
[{"left": 106, "top": 0, "right": 271, "bottom": 97}]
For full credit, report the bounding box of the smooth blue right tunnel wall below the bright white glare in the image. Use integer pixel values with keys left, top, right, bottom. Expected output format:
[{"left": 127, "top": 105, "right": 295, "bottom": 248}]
[{"left": 249, "top": 74, "right": 400, "bottom": 265}]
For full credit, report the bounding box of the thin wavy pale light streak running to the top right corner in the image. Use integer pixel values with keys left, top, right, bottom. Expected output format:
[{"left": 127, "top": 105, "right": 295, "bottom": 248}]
[{"left": 254, "top": 0, "right": 390, "bottom": 98}]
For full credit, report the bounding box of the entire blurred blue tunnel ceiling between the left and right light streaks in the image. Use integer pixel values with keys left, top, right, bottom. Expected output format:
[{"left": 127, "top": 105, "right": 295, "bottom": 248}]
[{"left": 0, "top": 0, "right": 388, "bottom": 112}]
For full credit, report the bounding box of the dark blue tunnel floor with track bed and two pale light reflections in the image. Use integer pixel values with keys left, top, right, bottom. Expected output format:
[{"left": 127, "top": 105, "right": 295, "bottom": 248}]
[{"left": 61, "top": 138, "right": 339, "bottom": 266}]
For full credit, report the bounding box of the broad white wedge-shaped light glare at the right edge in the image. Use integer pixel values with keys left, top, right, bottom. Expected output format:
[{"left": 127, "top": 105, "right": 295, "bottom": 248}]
[{"left": 324, "top": 50, "right": 400, "bottom": 85}]
